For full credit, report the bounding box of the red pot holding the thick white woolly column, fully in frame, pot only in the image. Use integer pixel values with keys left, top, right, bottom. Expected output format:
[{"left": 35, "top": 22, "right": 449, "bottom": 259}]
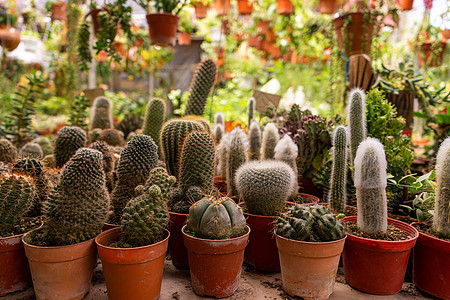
[{"left": 342, "top": 216, "right": 419, "bottom": 295}]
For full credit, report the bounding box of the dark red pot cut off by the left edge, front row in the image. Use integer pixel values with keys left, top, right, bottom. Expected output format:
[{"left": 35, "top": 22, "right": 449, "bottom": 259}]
[{"left": 0, "top": 234, "right": 31, "bottom": 297}]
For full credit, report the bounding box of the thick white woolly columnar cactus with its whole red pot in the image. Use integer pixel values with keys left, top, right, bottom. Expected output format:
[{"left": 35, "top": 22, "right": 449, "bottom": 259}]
[{"left": 342, "top": 138, "right": 419, "bottom": 295}]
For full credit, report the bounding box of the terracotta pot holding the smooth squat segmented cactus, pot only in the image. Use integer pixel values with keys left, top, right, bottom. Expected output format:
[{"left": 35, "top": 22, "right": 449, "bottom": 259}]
[{"left": 182, "top": 226, "right": 250, "bottom": 298}]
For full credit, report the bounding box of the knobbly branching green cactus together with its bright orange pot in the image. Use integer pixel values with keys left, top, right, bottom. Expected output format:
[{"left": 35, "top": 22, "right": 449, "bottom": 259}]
[{"left": 95, "top": 167, "right": 176, "bottom": 299}]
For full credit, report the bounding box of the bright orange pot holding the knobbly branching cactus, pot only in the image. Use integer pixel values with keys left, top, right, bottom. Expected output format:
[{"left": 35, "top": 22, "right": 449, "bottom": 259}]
[{"left": 95, "top": 228, "right": 170, "bottom": 300}]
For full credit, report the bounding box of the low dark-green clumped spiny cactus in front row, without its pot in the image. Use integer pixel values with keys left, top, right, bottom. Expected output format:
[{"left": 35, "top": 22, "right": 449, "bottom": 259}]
[{"left": 275, "top": 204, "right": 345, "bottom": 242}]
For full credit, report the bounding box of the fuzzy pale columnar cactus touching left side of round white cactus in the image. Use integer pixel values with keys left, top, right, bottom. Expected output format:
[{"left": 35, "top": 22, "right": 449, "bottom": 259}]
[{"left": 226, "top": 127, "right": 248, "bottom": 197}]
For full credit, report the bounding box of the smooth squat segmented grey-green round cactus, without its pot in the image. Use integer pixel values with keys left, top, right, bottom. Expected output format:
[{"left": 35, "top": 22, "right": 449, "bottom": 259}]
[{"left": 186, "top": 195, "right": 246, "bottom": 239}]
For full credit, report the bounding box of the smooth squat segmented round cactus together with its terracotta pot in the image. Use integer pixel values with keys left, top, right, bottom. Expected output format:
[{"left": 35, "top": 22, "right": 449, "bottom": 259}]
[{"left": 182, "top": 193, "right": 250, "bottom": 298}]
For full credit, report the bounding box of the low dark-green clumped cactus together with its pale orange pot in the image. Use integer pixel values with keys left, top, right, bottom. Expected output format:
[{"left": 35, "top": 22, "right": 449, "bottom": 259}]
[{"left": 275, "top": 204, "right": 346, "bottom": 299}]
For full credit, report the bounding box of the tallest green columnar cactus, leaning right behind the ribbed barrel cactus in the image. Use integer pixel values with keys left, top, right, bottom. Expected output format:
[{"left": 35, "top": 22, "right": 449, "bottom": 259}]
[{"left": 184, "top": 58, "right": 217, "bottom": 116}]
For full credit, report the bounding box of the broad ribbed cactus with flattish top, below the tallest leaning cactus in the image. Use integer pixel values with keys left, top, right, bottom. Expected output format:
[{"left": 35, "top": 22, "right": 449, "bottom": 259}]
[{"left": 161, "top": 120, "right": 203, "bottom": 178}]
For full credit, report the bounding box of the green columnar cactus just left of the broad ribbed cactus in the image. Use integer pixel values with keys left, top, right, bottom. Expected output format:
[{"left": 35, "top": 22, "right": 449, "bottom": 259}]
[{"left": 142, "top": 98, "right": 166, "bottom": 157}]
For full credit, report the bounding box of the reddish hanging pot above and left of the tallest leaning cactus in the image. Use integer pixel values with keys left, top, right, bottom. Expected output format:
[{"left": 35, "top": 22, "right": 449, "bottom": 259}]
[{"left": 146, "top": 13, "right": 179, "bottom": 46}]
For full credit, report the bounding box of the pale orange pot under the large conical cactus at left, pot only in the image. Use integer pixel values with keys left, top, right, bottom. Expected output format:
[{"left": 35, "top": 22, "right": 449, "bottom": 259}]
[{"left": 22, "top": 230, "right": 97, "bottom": 299}]
